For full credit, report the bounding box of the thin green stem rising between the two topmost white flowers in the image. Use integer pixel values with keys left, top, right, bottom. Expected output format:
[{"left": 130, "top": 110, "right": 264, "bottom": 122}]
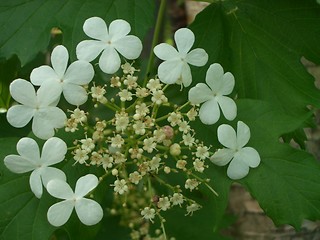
[{"left": 143, "top": 0, "right": 167, "bottom": 87}]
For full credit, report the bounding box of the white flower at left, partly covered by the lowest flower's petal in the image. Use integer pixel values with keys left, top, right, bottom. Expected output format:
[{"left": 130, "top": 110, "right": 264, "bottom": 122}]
[{"left": 4, "top": 137, "right": 67, "bottom": 198}]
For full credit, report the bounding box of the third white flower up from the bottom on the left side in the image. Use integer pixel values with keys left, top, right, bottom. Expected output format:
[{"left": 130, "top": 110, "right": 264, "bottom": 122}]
[{"left": 7, "top": 79, "right": 67, "bottom": 139}]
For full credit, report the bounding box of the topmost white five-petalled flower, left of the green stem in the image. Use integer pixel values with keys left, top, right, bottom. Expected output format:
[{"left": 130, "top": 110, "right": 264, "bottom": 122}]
[{"left": 76, "top": 17, "right": 142, "bottom": 74}]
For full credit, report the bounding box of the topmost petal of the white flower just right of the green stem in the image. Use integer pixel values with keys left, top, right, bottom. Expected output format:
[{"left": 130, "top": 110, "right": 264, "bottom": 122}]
[{"left": 174, "top": 28, "right": 195, "bottom": 54}]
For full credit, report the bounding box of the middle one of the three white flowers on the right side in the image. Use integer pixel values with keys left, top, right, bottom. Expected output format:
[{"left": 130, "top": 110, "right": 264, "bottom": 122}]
[{"left": 189, "top": 63, "right": 237, "bottom": 124}]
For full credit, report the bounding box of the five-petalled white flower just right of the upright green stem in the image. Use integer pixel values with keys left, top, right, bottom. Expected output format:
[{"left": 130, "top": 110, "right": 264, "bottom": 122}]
[{"left": 153, "top": 28, "right": 208, "bottom": 87}]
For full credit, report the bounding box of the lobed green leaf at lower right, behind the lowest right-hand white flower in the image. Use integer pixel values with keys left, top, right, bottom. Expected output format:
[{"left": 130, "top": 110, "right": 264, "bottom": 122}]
[{"left": 238, "top": 100, "right": 320, "bottom": 229}]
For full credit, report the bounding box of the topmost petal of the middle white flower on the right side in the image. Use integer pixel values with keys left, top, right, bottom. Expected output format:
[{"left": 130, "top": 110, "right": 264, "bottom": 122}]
[{"left": 206, "top": 63, "right": 224, "bottom": 93}]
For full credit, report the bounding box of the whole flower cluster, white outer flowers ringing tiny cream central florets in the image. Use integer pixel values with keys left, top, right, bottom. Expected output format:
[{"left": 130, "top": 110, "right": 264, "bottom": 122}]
[{"left": 4, "top": 17, "right": 260, "bottom": 239}]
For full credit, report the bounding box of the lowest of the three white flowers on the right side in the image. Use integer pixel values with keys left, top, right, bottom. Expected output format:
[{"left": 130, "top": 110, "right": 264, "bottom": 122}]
[{"left": 211, "top": 121, "right": 260, "bottom": 179}]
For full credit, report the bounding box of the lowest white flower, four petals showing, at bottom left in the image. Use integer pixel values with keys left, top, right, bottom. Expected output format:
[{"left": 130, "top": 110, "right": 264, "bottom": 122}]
[{"left": 47, "top": 174, "right": 103, "bottom": 227}]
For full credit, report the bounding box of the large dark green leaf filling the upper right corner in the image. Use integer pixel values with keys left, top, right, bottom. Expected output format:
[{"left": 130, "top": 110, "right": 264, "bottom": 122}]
[{"left": 190, "top": 0, "right": 320, "bottom": 115}]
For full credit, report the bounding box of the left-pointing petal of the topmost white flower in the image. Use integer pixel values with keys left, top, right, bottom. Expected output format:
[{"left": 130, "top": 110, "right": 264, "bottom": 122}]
[{"left": 76, "top": 40, "right": 107, "bottom": 62}]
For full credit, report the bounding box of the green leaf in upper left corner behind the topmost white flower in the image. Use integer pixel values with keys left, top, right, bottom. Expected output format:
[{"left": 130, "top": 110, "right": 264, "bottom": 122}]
[{"left": 0, "top": 0, "right": 154, "bottom": 66}]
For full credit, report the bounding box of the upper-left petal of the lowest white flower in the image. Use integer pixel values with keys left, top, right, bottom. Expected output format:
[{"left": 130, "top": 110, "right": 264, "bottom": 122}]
[{"left": 47, "top": 179, "right": 74, "bottom": 199}]
